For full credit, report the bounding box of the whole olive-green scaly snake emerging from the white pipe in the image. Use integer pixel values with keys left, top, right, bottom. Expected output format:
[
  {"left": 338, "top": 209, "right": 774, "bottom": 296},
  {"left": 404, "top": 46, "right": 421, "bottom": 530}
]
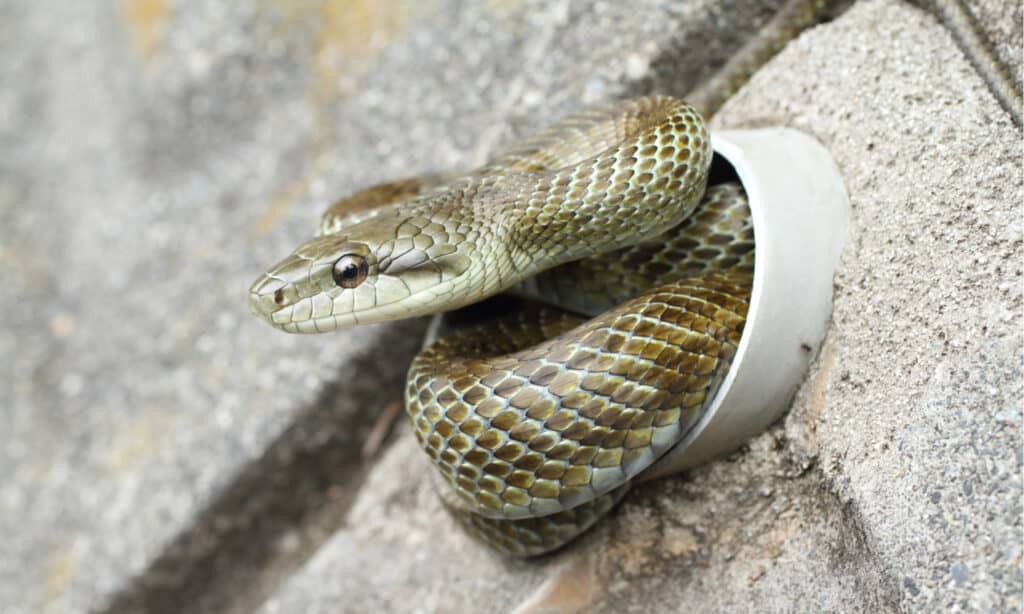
[{"left": 249, "top": 0, "right": 1019, "bottom": 557}]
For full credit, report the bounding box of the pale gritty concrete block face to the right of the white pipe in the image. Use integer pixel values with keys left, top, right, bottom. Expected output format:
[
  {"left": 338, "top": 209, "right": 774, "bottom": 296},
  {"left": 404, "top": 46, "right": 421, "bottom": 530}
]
[{"left": 717, "top": 2, "right": 1024, "bottom": 611}]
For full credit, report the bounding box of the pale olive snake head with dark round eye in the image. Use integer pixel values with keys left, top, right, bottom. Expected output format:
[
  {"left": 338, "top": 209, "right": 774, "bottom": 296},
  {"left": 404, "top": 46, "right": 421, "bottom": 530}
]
[{"left": 249, "top": 216, "right": 470, "bottom": 333}]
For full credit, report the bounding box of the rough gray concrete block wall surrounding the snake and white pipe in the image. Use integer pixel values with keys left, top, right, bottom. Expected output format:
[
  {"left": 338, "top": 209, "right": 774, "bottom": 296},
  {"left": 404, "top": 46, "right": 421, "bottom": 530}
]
[{"left": 0, "top": 0, "right": 1024, "bottom": 612}]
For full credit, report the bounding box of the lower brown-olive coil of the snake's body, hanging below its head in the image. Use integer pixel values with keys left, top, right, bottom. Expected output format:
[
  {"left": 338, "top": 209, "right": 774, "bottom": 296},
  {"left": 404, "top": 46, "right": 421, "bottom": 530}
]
[{"left": 407, "top": 273, "right": 750, "bottom": 556}]
